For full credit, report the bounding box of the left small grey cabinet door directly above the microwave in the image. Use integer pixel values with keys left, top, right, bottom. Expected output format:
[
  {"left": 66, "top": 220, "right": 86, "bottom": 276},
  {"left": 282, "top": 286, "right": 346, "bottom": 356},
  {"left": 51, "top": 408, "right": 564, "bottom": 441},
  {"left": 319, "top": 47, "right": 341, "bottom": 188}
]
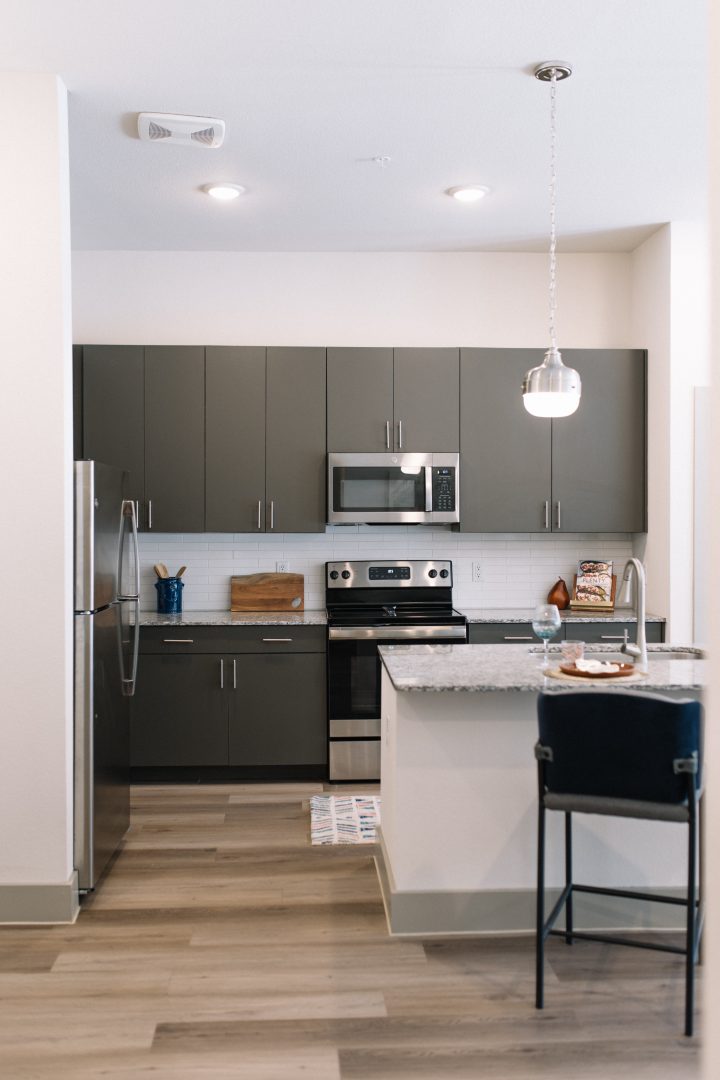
[{"left": 327, "top": 349, "right": 395, "bottom": 454}]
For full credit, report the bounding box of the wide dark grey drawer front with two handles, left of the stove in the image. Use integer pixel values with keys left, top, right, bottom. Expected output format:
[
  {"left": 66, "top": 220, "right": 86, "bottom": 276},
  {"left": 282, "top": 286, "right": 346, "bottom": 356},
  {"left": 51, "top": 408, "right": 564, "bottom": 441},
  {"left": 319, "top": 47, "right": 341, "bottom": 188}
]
[{"left": 140, "top": 624, "right": 327, "bottom": 653}]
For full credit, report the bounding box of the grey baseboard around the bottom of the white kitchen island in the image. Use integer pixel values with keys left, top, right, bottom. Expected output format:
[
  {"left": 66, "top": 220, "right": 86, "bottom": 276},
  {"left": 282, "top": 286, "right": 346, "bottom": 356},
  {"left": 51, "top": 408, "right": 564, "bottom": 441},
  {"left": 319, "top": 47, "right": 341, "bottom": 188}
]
[{"left": 376, "top": 828, "right": 684, "bottom": 937}]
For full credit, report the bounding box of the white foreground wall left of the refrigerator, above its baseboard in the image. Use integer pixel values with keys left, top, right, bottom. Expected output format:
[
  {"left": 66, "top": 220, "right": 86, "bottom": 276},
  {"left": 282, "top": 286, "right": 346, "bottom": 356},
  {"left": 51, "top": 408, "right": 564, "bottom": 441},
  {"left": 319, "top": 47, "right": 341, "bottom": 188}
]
[{"left": 0, "top": 73, "right": 72, "bottom": 898}]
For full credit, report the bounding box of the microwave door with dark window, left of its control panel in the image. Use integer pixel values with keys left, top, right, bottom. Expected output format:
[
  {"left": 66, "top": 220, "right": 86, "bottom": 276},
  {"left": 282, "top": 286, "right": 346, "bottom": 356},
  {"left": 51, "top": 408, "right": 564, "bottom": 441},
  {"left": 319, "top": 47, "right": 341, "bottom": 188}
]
[{"left": 327, "top": 454, "right": 433, "bottom": 525}]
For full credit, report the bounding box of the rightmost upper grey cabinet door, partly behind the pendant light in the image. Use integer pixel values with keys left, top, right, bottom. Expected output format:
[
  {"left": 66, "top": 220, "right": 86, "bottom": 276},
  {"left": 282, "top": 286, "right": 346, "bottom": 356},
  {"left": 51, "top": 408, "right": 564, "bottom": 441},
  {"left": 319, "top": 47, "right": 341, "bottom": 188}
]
[{"left": 553, "top": 349, "right": 647, "bottom": 532}]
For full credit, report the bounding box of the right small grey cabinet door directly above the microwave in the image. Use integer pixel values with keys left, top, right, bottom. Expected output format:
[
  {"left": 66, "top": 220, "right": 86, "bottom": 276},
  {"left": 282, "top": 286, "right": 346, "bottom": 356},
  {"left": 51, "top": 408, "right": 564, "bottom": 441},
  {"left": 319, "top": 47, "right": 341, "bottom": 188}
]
[{"left": 394, "top": 349, "right": 460, "bottom": 454}]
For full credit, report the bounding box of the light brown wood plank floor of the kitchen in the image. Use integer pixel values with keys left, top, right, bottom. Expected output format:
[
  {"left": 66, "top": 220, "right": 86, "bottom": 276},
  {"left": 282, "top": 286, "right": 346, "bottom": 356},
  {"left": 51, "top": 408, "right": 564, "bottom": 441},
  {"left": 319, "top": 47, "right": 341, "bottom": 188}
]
[{"left": 0, "top": 784, "right": 702, "bottom": 1080}]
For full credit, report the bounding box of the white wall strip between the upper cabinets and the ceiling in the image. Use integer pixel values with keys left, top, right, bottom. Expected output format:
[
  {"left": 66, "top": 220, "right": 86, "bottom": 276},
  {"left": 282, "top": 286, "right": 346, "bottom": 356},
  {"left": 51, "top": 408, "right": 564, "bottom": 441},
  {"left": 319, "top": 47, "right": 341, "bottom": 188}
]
[{"left": 73, "top": 252, "right": 630, "bottom": 343}]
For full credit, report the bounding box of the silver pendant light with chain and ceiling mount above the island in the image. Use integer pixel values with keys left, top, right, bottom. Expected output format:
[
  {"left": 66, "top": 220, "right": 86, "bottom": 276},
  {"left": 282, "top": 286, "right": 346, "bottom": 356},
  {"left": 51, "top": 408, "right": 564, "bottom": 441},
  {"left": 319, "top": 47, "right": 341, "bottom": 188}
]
[{"left": 522, "top": 62, "right": 581, "bottom": 417}]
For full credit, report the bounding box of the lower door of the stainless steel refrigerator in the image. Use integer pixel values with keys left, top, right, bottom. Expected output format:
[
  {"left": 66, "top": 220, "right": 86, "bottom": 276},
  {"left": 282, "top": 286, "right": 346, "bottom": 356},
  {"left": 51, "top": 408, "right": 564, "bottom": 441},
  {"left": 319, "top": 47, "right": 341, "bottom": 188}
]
[{"left": 74, "top": 604, "right": 130, "bottom": 890}]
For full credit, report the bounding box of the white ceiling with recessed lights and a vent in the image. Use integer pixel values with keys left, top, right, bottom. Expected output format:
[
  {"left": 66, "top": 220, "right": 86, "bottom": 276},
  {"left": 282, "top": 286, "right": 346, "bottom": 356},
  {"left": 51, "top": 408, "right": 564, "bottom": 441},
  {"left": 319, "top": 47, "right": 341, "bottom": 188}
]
[{"left": 0, "top": 0, "right": 707, "bottom": 252}]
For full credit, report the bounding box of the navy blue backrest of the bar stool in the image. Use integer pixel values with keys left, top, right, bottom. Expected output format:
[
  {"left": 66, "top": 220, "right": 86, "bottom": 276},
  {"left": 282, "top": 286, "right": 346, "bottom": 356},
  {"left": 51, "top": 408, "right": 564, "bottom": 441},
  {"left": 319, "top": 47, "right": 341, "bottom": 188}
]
[{"left": 538, "top": 691, "right": 702, "bottom": 804}]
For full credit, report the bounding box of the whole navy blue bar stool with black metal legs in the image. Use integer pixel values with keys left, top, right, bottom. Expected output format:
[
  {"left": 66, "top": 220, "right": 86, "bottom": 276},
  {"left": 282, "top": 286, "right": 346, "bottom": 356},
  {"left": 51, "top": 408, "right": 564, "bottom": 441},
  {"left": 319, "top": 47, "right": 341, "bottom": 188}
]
[{"left": 535, "top": 689, "right": 703, "bottom": 1036}]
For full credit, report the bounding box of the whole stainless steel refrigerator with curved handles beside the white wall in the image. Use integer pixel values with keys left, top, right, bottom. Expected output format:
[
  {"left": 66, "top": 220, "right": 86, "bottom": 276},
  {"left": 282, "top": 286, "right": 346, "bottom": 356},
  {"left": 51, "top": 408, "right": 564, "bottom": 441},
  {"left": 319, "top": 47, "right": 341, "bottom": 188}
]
[{"left": 74, "top": 461, "right": 139, "bottom": 891}]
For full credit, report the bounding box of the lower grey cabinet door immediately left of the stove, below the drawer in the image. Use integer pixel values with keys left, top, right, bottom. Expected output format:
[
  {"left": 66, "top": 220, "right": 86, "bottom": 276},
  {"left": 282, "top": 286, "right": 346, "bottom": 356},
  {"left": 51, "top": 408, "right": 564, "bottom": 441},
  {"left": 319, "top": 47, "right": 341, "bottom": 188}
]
[{"left": 228, "top": 653, "right": 327, "bottom": 766}]
